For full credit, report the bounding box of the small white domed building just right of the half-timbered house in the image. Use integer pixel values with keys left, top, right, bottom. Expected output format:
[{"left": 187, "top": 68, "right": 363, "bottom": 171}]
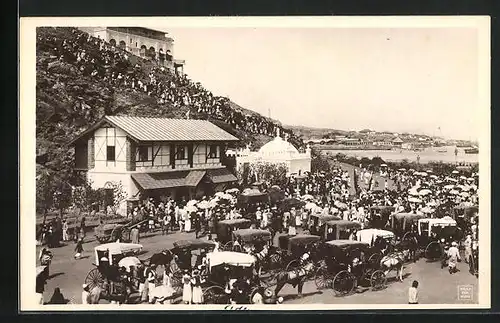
[{"left": 236, "top": 131, "right": 311, "bottom": 175}]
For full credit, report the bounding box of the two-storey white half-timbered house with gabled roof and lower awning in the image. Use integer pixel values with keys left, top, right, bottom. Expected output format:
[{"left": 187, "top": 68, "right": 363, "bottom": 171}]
[{"left": 70, "top": 116, "right": 238, "bottom": 215}]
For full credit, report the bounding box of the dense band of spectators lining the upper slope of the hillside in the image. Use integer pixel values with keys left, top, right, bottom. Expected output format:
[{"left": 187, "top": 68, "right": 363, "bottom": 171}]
[{"left": 38, "top": 28, "right": 301, "bottom": 147}]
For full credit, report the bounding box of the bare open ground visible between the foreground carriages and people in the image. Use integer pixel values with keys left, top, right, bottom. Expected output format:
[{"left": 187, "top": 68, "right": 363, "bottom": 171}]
[{"left": 38, "top": 227, "right": 478, "bottom": 304}]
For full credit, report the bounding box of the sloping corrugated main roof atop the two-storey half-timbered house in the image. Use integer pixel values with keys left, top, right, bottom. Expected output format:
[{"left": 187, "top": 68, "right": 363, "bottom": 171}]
[{"left": 105, "top": 116, "right": 238, "bottom": 141}]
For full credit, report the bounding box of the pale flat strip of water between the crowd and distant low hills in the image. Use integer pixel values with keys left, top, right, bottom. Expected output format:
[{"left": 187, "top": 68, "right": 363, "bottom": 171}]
[{"left": 321, "top": 146, "right": 479, "bottom": 163}]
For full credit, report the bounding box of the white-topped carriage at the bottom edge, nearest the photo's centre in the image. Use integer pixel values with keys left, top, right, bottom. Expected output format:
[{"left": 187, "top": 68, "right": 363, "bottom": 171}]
[{"left": 202, "top": 251, "right": 265, "bottom": 304}]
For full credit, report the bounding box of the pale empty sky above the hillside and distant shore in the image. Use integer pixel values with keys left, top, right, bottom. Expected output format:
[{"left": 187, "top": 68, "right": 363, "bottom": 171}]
[{"left": 162, "top": 27, "right": 479, "bottom": 140}]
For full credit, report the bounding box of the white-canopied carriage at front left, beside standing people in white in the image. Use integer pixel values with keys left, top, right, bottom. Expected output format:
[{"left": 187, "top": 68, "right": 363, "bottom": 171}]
[{"left": 85, "top": 242, "right": 142, "bottom": 302}]
